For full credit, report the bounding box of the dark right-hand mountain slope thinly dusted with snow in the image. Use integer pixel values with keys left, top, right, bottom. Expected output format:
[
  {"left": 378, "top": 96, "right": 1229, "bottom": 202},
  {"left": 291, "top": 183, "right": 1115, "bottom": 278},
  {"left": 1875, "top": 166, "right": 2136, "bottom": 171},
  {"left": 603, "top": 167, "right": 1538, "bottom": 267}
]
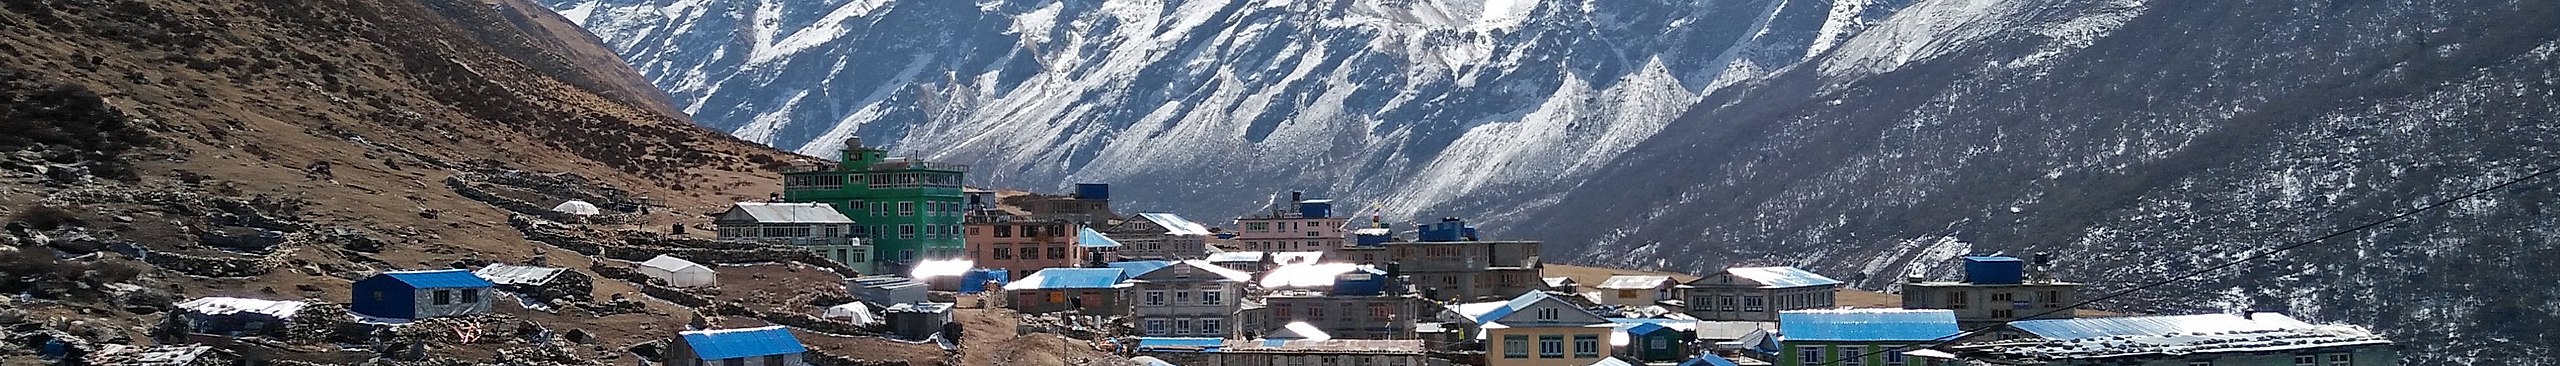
[{"left": 1516, "top": 0, "right": 2560, "bottom": 366}]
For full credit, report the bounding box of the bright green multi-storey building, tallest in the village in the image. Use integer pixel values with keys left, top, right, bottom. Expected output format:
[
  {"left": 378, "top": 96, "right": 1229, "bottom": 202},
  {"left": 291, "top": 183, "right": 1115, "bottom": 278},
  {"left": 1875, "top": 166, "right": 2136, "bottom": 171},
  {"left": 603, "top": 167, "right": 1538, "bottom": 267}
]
[{"left": 783, "top": 138, "right": 968, "bottom": 274}]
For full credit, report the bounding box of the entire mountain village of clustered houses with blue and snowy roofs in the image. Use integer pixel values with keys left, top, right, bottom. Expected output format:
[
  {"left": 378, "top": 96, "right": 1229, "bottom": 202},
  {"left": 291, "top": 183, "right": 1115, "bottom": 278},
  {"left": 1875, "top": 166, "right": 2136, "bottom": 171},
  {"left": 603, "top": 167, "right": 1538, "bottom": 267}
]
[{"left": 41, "top": 141, "right": 2399, "bottom": 366}]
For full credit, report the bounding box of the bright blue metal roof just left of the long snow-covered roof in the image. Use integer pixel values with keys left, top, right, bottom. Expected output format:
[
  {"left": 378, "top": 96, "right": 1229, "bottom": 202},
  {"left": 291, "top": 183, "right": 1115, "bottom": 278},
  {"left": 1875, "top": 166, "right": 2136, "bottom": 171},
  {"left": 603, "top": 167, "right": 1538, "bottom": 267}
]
[{"left": 1777, "top": 310, "right": 1961, "bottom": 343}]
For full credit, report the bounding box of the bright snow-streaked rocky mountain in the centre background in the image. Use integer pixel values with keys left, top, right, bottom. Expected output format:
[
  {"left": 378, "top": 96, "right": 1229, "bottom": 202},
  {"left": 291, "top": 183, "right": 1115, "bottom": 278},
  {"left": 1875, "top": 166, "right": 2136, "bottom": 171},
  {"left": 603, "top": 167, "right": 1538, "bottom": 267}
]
[{"left": 548, "top": 0, "right": 1900, "bottom": 218}]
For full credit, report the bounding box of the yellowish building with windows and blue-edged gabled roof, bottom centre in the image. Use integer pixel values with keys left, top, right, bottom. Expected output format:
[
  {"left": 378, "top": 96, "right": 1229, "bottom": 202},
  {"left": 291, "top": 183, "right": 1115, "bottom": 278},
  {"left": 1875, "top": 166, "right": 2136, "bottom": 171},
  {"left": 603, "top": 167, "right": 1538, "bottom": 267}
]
[{"left": 1464, "top": 292, "right": 1615, "bottom": 366}]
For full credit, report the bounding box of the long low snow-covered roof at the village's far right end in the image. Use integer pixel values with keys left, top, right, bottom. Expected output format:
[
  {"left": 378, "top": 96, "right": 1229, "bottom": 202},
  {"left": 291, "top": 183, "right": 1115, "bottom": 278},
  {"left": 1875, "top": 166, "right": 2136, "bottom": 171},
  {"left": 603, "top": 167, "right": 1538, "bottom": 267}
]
[{"left": 1964, "top": 315, "right": 2391, "bottom": 358}]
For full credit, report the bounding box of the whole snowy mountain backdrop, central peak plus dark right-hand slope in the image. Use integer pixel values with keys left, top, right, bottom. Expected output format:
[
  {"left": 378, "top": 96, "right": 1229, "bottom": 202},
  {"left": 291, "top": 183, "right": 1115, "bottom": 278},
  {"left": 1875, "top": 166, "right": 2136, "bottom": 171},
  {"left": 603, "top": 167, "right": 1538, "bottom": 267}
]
[{"left": 550, "top": 0, "right": 2560, "bottom": 366}]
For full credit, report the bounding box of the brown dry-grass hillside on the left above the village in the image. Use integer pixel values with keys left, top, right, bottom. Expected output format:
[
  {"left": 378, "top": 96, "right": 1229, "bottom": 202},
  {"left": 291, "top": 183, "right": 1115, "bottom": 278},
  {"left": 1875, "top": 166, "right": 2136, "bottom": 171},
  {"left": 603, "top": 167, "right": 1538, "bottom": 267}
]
[{"left": 0, "top": 0, "right": 1116, "bottom": 363}]
